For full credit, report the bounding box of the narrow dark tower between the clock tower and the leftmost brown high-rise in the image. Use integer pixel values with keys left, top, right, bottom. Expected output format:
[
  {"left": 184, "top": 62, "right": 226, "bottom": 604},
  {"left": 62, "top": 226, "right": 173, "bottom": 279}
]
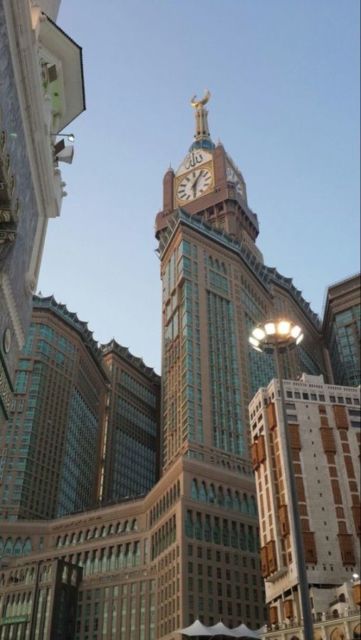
[{"left": 100, "top": 340, "right": 160, "bottom": 503}]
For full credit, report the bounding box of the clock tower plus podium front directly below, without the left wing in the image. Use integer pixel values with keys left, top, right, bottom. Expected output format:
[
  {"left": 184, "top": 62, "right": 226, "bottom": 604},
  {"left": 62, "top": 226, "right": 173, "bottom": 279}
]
[{"left": 152, "top": 92, "right": 323, "bottom": 639}]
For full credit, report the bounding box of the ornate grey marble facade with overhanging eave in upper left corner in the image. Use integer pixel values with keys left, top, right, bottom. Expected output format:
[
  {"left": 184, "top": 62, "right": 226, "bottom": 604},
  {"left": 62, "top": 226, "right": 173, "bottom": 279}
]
[{"left": 0, "top": 0, "right": 85, "bottom": 425}]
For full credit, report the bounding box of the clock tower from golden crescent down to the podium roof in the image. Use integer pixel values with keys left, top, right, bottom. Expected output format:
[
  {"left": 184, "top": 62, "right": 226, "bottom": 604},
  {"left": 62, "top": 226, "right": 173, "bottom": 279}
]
[{"left": 156, "top": 96, "right": 324, "bottom": 469}]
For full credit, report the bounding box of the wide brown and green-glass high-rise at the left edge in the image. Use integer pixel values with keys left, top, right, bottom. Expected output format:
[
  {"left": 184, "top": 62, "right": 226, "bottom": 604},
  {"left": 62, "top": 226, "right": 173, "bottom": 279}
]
[{"left": 0, "top": 296, "right": 108, "bottom": 520}]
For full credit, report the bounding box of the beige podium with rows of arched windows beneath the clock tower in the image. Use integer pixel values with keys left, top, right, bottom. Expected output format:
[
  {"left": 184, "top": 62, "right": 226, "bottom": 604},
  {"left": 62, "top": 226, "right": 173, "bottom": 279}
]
[{"left": 0, "top": 458, "right": 263, "bottom": 640}]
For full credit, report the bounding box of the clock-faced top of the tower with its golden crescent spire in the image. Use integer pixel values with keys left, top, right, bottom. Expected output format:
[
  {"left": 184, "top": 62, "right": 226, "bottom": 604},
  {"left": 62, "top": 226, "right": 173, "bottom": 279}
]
[{"left": 156, "top": 91, "right": 263, "bottom": 261}]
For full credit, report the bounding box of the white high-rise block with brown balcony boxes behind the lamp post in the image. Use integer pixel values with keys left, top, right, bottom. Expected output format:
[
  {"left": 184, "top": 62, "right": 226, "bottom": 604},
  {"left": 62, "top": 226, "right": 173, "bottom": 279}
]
[{"left": 250, "top": 375, "right": 361, "bottom": 640}]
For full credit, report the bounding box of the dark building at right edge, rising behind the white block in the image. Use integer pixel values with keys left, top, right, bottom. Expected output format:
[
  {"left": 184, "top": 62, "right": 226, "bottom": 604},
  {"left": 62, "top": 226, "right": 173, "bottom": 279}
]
[{"left": 323, "top": 274, "right": 361, "bottom": 386}]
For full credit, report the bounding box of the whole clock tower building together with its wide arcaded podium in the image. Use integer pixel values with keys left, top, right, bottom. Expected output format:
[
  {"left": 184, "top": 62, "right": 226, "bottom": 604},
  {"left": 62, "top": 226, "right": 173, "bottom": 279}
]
[{"left": 0, "top": 96, "right": 334, "bottom": 640}]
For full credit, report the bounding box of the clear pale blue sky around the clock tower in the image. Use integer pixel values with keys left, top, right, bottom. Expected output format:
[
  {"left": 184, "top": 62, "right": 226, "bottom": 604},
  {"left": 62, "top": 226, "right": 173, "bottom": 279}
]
[{"left": 38, "top": 0, "right": 360, "bottom": 371}]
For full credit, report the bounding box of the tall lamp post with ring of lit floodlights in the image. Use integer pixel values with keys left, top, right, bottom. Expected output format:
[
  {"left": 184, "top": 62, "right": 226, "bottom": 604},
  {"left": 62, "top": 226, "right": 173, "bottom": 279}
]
[{"left": 249, "top": 319, "right": 313, "bottom": 640}]
